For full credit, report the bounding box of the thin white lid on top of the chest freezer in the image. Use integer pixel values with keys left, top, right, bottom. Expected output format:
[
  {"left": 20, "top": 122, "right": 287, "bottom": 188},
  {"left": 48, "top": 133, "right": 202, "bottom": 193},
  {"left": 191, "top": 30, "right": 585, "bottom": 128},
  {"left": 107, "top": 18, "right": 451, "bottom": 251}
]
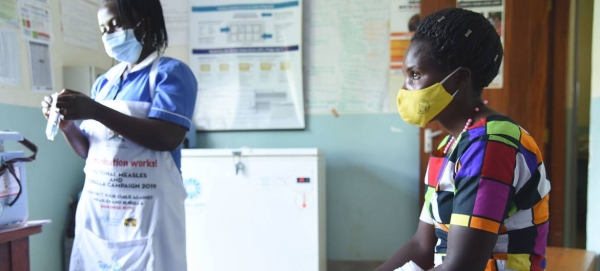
[{"left": 181, "top": 148, "right": 320, "bottom": 157}]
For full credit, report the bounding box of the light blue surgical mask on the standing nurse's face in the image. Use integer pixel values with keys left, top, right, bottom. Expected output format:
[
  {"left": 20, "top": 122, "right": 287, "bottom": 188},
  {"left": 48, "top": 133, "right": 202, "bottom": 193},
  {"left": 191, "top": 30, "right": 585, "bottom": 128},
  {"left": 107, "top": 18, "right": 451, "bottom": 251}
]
[{"left": 102, "top": 22, "right": 143, "bottom": 63}]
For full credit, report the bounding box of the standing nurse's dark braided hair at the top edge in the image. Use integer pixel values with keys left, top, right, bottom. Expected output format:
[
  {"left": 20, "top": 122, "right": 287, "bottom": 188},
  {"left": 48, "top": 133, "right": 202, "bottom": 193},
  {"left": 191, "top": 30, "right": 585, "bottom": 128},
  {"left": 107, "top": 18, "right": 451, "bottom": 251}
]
[{"left": 104, "top": 0, "right": 169, "bottom": 52}]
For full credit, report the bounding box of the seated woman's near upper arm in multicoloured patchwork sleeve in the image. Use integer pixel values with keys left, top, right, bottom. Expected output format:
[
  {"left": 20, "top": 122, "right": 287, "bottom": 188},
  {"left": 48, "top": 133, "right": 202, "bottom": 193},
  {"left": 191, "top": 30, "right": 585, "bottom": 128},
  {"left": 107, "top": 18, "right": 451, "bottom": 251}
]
[{"left": 433, "top": 136, "right": 517, "bottom": 271}]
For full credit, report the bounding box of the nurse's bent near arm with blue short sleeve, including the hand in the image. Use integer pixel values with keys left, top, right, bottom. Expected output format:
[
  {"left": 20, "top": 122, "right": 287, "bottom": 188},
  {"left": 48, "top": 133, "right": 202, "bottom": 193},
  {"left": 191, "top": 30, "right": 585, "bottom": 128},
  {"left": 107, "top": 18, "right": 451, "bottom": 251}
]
[{"left": 57, "top": 60, "right": 198, "bottom": 151}]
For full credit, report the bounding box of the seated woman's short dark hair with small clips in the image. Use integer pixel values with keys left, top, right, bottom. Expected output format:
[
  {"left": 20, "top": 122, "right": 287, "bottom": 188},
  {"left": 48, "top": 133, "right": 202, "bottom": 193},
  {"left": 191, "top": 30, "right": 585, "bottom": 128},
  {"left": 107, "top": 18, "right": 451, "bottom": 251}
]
[{"left": 412, "top": 8, "right": 504, "bottom": 96}]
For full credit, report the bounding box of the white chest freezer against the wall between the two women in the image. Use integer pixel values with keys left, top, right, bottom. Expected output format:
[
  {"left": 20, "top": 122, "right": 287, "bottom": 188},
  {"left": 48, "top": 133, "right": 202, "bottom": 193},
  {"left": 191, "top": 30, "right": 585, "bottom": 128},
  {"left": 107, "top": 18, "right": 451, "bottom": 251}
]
[{"left": 182, "top": 149, "right": 327, "bottom": 271}]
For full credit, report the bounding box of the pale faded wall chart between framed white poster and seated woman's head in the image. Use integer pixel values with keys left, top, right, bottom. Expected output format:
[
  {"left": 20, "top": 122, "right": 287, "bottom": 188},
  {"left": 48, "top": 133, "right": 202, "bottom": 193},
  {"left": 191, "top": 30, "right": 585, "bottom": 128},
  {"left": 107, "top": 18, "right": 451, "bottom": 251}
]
[{"left": 304, "top": 0, "right": 390, "bottom": 115}]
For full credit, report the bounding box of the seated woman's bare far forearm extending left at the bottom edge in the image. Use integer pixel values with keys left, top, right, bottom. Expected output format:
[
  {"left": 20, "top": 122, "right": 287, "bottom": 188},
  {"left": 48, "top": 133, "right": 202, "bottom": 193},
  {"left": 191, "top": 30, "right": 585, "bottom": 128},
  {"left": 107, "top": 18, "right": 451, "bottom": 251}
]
[{"left": 374, "top": 221, "right": 437, "bottom": 271}]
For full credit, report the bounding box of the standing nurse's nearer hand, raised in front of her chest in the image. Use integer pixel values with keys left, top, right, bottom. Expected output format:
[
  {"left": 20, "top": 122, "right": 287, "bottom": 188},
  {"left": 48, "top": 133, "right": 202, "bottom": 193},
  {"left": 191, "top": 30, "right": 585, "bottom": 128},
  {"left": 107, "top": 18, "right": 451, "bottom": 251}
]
[{"left": 56, "top": 89, "right": 100, "bottom": 121}]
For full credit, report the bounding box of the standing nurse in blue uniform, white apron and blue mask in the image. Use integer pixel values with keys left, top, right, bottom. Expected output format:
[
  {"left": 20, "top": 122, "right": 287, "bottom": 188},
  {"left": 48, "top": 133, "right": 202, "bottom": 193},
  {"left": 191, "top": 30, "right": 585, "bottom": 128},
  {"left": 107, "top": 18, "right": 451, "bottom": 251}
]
[{"left": 42, "top": 0, "right": 197, "bottom": 271}]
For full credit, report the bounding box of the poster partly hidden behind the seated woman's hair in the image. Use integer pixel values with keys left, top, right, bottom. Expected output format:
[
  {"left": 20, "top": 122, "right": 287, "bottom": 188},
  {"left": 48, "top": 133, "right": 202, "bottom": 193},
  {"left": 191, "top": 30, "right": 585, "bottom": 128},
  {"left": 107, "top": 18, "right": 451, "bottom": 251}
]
[{"left": 456, "top": 0, "right": 505, "bottom": 89}]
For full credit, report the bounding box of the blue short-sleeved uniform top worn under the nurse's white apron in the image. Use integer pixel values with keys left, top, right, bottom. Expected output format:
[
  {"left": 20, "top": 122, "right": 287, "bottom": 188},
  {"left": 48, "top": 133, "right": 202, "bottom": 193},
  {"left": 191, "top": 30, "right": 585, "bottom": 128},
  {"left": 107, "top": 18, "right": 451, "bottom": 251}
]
[{"left": 84, "top": 53, "right": 198, "bottom": 169}]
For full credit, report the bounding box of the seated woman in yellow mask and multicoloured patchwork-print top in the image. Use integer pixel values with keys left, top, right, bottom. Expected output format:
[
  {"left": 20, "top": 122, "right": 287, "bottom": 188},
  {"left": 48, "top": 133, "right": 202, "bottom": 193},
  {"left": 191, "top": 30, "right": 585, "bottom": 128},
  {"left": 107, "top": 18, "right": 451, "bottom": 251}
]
[{"left": 376, "top": 8, "right": 550, "bottom": 271}]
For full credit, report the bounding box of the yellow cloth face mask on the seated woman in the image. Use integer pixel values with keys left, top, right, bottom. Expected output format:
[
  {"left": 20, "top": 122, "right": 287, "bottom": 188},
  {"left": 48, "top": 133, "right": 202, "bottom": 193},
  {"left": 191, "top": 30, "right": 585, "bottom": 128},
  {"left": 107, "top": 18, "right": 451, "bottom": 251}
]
[{"left": 396, "top": 67, "right": 460, "bottom": 127}]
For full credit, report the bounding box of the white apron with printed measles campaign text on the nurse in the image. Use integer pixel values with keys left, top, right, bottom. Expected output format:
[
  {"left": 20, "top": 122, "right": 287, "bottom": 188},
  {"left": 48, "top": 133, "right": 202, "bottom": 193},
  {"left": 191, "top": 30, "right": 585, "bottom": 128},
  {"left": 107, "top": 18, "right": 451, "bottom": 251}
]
[{"left": 70, "top": 58, "right": 187, "bottom": 271}]
